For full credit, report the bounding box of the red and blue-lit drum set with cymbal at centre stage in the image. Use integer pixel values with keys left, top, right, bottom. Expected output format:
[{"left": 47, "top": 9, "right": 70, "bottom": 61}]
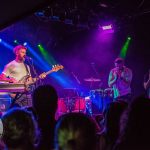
[{"left": 58, "top": 77, "right": 113, "bottom": 115}]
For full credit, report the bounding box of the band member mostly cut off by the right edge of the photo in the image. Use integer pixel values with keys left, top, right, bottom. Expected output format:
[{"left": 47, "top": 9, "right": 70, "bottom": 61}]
[{"left": 144, "top": 69, "right": 150, "bottom": 98}]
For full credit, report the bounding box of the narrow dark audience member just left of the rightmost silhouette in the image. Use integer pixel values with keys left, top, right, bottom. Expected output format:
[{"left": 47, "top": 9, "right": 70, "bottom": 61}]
[{"left": 99, "top": 101, "right": 128, "bottom": 150}]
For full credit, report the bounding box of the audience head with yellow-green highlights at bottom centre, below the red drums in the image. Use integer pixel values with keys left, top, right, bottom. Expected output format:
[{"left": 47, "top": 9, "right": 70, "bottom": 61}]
[{"left": 55, "top": 113, "right": 96, "bottom": 150}]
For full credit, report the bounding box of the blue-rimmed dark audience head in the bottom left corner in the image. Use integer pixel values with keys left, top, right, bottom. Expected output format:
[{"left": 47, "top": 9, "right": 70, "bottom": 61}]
[{"left": 1, "top": 108, "right": 39, "bottom": 150}]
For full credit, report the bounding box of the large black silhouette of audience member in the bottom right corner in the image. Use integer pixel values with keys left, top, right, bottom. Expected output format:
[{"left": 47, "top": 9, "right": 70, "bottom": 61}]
[{"left": 114, "top": 96, "right": 150, "bottom": 150}]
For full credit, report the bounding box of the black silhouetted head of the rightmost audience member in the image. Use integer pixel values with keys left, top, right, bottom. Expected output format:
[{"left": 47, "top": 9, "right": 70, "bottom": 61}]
[{"left": 123, "top": 96, "right": 150, "bottom": 141}]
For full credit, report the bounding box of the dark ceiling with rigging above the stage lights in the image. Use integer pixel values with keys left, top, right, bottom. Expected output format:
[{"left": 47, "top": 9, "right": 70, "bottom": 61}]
[{"left": 0, "top": 0, "right": 150, "bottom": 29}]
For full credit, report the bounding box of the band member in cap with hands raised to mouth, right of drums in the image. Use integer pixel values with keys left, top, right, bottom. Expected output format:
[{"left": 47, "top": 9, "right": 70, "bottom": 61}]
[{"left": 108, "top": 58, "right": 132, "bottom": 103}]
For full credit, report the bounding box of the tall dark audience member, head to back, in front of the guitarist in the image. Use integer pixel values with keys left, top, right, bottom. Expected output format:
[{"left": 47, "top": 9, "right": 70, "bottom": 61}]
[{"left": 32, "top": 85, "right": 58, "bottom": 150}]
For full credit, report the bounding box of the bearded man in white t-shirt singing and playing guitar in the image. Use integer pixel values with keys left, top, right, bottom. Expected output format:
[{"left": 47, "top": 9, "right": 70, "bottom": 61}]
[{"left": 0, "top": 45, "right": 46, "bottom": 106}]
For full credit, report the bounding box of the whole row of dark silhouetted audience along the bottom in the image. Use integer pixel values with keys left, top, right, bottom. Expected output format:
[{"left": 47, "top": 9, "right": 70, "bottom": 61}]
[{"left": 0, "top": 85, "right": 150, "bottom": 150}]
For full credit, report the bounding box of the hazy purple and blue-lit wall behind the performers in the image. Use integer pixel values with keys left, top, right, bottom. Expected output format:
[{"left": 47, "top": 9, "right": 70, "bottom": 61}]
[{"left": 0, "top": 15, "right": 150, "bottom": 96}]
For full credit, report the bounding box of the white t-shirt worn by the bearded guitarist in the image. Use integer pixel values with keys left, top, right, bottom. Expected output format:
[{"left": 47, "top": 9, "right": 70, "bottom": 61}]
[{"left": 3, "top": 60, "right": 30, "bottom": 81}]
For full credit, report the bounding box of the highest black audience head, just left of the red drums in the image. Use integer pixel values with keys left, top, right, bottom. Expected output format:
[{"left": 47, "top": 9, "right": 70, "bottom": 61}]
[{"left": 32, "top": 84, "right": 58, "bottom": 116}]
